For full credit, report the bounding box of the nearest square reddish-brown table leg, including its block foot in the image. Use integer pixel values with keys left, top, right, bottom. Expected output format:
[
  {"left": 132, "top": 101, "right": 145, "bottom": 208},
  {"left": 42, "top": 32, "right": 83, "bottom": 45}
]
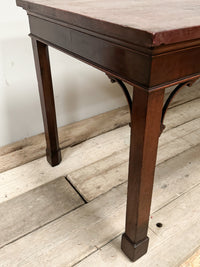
[{"left": 122, "top": 87, "right": 164, "bottom": 261}]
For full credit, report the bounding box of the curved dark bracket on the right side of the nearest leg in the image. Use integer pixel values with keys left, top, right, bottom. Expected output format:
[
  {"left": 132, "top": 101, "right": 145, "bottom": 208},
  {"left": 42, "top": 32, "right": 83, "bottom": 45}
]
[{"left": 160, "top": 78, "right": 198, "bottom": 134}]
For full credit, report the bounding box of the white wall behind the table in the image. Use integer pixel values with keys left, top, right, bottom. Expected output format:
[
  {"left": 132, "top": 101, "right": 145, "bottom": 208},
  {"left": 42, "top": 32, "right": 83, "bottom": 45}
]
[{"left": 0, "top": 0, "right": 130, "bottom": 146}]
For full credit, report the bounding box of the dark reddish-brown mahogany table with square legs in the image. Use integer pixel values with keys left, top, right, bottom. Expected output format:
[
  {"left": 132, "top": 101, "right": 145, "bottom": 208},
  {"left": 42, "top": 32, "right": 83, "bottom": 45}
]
[{"left": 17, "top": 0, "right": 200, "bottom": 261}]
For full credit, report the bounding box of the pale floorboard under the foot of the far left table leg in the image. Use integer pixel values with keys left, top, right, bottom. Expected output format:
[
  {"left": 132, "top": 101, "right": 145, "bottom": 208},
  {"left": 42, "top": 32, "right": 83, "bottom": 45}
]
[{"left": 0, "top": 127, "right": 129, "bottom": 203}]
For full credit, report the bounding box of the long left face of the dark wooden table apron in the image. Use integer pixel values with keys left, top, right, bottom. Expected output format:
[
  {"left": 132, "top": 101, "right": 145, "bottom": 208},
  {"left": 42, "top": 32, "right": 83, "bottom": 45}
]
[{"left": 29, "top": 15, "right": 151, "bottom": 85}]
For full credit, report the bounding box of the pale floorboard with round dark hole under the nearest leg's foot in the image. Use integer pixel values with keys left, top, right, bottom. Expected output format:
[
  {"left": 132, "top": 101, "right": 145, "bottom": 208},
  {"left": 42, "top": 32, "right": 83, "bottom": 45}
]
[{"left": 76, "top": 177, "right": 200, "bottom": 267}]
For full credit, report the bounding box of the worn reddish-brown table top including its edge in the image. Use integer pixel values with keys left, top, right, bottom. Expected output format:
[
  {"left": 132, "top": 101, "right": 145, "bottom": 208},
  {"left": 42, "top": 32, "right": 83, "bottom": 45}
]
[{"left": 17, "top": 0, "right": 200, "bottom": 46}]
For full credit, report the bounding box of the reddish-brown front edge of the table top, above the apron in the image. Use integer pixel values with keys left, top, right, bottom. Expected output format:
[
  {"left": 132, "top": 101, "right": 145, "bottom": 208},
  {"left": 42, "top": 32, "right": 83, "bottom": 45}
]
[{"left": 16, "top": 0, "right": 200, "bottom": 48}]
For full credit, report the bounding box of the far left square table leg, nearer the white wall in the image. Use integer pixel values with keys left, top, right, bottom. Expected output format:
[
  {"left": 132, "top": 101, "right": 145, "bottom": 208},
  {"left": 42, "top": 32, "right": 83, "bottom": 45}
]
[{"left": 32, "top": 37, "right": 61, "bottom": 166}]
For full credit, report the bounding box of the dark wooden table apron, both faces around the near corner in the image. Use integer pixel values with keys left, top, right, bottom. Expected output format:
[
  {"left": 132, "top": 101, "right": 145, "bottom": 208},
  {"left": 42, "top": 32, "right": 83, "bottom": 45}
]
[{"left": 29, "top": 14, "right": 200, "bottom": 90}]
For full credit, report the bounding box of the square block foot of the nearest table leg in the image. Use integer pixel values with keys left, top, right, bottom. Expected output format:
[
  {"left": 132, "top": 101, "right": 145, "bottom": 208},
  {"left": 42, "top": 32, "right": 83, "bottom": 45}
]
[{"left": 121, "top": 233, "right": 149, "bottom": 261}]
